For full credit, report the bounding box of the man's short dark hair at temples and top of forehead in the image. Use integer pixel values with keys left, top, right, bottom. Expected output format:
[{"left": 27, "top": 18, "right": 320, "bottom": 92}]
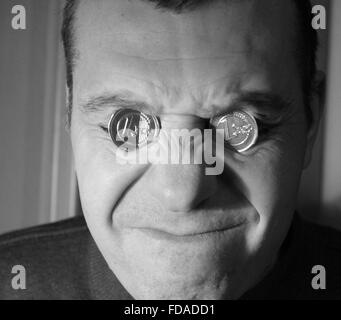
[{"left": 62, "top": 0, "right": 318, "bottom": 124}]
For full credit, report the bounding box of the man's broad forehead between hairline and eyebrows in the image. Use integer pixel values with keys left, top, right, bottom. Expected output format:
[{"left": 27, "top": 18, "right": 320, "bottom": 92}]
[{"left": 74, "top": 0, "right": 297, "bottom": 111}]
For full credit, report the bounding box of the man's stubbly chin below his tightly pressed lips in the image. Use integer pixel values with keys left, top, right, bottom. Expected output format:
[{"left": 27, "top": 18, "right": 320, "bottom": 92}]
[{"left": 106, "top": 249, "right": 247, "bottom": 300}]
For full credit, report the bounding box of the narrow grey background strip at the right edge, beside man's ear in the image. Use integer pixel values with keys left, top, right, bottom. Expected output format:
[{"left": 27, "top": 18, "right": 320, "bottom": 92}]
[{"left": 320, "top": 0, "right": 341, "bottom": 229}]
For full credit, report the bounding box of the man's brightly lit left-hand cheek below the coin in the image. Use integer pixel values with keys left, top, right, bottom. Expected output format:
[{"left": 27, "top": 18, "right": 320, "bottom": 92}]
[{"left": 72, "top": 119, "right": 144, "bottom": 226}]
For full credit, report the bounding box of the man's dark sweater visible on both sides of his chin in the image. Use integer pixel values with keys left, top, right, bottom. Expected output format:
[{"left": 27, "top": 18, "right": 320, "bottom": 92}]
[{"left": 0, "top": 216, "right": 341, "bottom": 300}]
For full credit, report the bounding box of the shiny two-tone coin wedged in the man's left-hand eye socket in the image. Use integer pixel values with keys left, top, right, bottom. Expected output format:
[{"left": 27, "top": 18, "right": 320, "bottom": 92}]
[{"left": 108, "top": 109, "right": 160, "bottom": 151}]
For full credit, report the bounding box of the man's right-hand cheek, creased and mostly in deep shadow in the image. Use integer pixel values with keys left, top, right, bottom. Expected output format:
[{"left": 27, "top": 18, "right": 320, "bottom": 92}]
[{"left": 227, "top": 127, "right": 305, "bottom": 247}]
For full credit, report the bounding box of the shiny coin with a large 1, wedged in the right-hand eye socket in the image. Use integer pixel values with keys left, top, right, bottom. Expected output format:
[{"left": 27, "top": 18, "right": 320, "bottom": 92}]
[{"left": 212, "top": 111, "right": 258, "bottom": 152}]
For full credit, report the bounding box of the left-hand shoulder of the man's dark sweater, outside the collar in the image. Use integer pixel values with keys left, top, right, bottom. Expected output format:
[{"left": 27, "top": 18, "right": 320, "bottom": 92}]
[{"left": 0, "top": 217, "right": 91, "bottom": 299}]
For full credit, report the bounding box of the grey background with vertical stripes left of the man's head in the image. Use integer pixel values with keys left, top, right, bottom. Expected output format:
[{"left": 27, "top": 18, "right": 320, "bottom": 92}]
[{"left": 0, "top": 0, "right": 76, "bottom": 233}]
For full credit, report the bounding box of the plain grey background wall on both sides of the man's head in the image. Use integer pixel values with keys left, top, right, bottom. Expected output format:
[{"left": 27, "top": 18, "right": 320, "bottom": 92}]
[{"left": 0, "top": 0, "right": 341, "bottom": 233}]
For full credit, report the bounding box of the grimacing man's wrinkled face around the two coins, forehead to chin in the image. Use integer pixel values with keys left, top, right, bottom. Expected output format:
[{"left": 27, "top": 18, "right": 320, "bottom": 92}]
[{"left": 71, "top": 0, "right": 314, "bottom": 299}]
